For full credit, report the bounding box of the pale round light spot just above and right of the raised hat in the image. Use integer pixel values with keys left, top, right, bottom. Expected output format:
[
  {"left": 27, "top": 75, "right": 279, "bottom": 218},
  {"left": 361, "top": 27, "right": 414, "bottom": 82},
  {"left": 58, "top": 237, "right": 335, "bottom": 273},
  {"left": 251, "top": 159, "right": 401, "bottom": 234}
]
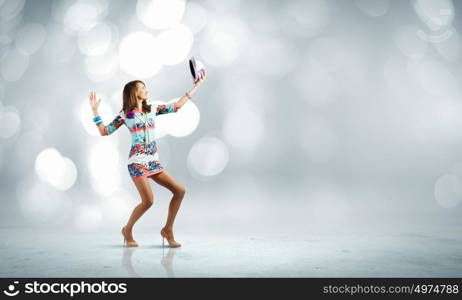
[{"left": 200, "top": 16, "right": 249, "bottom": 66}]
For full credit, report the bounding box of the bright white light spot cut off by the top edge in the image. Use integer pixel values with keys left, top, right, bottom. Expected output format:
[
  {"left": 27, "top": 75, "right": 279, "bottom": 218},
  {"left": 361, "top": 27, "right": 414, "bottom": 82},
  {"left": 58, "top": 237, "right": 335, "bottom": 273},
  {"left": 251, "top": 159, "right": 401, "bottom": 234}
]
[{"left": 136, "top": 0, "right": 185, "bottom": 29}]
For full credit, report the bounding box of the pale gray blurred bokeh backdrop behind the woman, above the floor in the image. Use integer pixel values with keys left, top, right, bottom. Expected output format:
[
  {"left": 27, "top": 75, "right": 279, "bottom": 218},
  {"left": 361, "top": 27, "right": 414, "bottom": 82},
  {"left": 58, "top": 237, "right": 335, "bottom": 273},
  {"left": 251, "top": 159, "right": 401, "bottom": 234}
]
[{"left": 0, "top": 0, "right": 462, "bottom": 238}]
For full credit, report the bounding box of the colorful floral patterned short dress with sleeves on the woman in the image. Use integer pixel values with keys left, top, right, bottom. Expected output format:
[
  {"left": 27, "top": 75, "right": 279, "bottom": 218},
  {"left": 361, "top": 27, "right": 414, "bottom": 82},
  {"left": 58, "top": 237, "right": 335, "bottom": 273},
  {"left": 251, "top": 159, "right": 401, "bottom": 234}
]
[{"left": 104, "top": 102, "right": 178, "bottom": 180}]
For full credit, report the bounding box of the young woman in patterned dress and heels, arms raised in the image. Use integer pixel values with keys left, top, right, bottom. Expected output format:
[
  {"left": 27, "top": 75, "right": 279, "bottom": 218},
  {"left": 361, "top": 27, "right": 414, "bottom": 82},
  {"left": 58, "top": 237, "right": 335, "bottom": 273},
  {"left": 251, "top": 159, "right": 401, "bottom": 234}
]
[{"left": 89, "top": 71, "right": 206, "bottom": 247}]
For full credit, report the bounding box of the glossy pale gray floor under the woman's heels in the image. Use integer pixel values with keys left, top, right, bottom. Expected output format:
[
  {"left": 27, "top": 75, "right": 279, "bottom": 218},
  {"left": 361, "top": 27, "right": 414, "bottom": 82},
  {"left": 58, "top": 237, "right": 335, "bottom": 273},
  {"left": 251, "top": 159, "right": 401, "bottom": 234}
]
[{"left": 0, "top": 227, "right": 462, "bottom": 277}]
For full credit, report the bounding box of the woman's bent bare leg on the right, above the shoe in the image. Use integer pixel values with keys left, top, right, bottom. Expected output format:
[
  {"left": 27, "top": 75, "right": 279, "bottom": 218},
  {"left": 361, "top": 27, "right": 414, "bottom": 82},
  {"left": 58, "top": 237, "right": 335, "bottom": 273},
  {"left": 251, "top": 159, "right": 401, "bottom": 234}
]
[{"left": 149, "top": 170, "right": 186, "bottom": 231}]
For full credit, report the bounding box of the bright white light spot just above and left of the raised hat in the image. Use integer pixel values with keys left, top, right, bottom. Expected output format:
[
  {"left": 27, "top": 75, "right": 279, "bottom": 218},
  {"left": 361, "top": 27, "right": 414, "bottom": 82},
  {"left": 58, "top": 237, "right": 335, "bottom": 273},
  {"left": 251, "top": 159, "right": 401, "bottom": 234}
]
[{"left": 157, "top": 24, "right": 194, "bottom": 65}]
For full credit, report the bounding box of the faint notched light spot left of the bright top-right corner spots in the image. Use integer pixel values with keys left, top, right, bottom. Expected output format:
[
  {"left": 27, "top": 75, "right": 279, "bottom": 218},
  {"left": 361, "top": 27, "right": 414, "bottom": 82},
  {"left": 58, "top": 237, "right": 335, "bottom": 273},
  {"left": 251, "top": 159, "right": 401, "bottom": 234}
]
[{"left": 394, "top": 24, "right": 427, "bottom": 58}]
